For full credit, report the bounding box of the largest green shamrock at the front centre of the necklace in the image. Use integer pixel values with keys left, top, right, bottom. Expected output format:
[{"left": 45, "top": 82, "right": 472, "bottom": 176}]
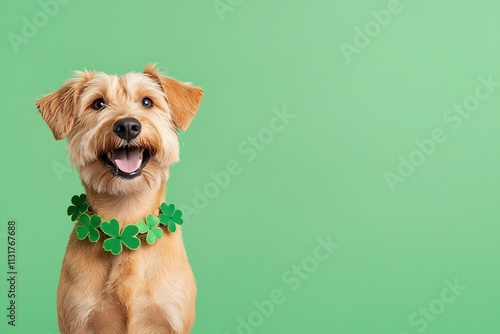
[{"left": 101, "top": 219, "right": 141, "bottom": 255}]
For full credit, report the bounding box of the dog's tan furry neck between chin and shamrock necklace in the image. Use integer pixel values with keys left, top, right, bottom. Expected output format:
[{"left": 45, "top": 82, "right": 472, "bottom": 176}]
[{"left": 84, "top": 184, "right": 166, "bottom": 227}]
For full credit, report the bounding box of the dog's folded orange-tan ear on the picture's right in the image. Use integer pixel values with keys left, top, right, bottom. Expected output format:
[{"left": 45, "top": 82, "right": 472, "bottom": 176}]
[{"left": 144, "top": 64, "right": 203, "bottom": 131}]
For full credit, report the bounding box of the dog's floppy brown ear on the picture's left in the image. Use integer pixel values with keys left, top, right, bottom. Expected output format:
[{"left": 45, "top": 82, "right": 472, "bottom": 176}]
[{"left": 36, "top": 72, "right": 90, "bottom": 140}]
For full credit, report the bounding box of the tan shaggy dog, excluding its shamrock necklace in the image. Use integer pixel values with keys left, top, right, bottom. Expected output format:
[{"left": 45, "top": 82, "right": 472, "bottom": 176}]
[{"left": 36, "top": 64, "right": 203, "bottom": 334}]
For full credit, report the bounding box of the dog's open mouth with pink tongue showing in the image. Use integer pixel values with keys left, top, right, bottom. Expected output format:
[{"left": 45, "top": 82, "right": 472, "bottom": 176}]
[{"left": 99, "top": 145, "right": 152, "bottom": 179}]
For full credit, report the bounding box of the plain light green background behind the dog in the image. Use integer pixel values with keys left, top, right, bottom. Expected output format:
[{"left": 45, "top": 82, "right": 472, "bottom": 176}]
[{"left": 0, "top": 0, "right": 500, "bottom": 334}]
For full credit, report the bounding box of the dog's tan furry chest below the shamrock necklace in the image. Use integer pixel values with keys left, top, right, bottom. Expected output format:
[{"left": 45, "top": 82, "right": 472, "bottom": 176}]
[{"left": 58, "top": 234, "right": 196, "bottom": 334}]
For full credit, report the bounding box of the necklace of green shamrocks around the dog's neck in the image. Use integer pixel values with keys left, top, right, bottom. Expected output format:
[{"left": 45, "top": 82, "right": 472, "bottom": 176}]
[{"left": 67, "top": 194, "right": 183, "bottom": 255}]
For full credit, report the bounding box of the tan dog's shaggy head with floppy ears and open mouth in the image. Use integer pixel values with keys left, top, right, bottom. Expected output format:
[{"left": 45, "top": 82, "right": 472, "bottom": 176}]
[{"left": 36, "top": 65, "right": 203, "bottom": 195}]
